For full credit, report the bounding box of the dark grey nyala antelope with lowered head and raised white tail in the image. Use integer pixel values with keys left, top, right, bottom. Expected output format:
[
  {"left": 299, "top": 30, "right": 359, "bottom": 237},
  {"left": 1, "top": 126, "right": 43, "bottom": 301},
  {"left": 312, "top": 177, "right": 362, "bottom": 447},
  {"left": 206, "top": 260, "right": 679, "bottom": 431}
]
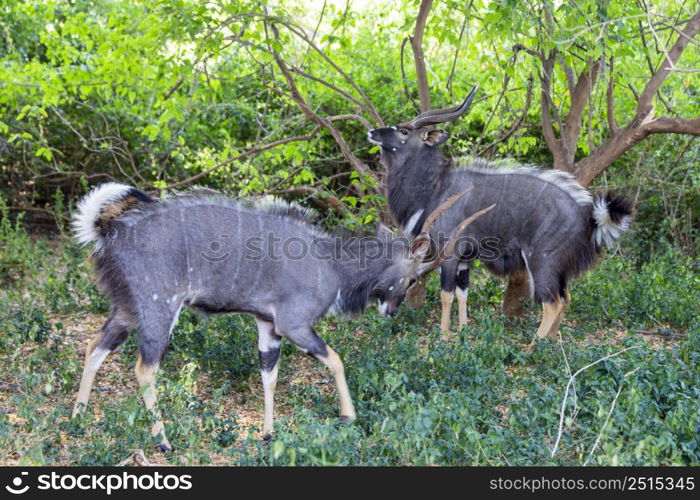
[{"left": 73, "top": 183, "right": 488, "bottom": 450}]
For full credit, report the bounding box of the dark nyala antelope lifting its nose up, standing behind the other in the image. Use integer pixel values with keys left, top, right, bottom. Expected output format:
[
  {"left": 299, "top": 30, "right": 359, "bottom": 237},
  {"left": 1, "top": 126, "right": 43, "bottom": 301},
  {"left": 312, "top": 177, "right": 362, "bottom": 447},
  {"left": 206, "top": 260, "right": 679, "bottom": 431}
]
[{"left": 368, "top": 88, "right": 632, "bottom": 344}]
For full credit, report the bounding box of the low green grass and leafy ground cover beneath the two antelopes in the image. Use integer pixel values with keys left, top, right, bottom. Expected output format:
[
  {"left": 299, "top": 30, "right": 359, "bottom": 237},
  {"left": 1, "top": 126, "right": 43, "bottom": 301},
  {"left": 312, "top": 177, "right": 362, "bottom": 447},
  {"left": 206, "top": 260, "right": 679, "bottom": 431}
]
[{"left": 0, "top": 211, "right": 700, "bottom": 465}]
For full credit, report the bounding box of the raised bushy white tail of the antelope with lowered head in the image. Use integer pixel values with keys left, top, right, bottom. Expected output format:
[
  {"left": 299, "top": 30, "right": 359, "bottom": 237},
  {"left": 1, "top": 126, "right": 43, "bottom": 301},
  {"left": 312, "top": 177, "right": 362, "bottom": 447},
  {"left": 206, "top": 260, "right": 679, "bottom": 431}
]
[{"left": 73, "top": 182, "right": 155, "bottom": 245}]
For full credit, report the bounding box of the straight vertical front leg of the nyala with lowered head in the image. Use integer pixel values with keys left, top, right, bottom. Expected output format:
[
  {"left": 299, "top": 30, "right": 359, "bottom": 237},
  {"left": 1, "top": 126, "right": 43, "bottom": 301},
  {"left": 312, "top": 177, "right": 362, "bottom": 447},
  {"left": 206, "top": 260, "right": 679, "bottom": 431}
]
[{"left": 255, "top": 317, "right": 281, "bottom": 440}]
